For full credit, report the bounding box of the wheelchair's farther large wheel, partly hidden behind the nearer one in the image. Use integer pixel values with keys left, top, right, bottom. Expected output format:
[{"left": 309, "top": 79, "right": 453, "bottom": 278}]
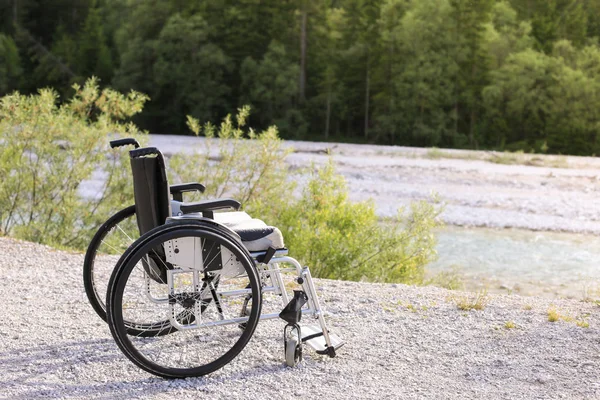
[{"left": 83, "top": 206, "right": 140, "bottom": 321}]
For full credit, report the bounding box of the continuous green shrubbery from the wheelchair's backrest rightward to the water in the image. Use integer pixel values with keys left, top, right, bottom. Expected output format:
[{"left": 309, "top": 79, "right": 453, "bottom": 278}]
[{"left": 169, "top": 114, "right": 439, "bottom": 283}]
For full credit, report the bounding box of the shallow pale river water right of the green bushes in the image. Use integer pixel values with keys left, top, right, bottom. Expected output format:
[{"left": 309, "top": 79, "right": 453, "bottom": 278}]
[{"left": 428, "top": 227, "right": 600, "bottom": 298}]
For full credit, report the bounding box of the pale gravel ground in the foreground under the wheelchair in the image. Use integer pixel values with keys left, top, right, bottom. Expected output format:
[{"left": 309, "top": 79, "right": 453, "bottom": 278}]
[{"left": 0, "top": 238, "right": 600, "bottom": 399}]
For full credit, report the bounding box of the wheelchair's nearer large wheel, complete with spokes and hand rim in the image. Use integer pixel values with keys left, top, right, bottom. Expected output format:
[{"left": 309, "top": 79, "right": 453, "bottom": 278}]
[{"left": 107, "top": 221, "right": 261, "bottom": 378}]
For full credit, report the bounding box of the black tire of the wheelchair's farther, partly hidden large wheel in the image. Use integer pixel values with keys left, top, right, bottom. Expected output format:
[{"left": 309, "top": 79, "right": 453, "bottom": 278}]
[{"left": 83, "top": 206, "right": 137, "bottom": 321}]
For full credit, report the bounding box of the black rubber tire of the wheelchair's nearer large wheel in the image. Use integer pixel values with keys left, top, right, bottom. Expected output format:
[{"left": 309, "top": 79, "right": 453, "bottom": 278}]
[{"left": 107, "top": 220, "right": 262, "bottom": 378}]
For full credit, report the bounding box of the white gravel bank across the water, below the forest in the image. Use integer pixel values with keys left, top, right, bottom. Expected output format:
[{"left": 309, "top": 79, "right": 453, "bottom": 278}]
[{"left": 150, "top": 135, "right": 600, "bottom": 234}]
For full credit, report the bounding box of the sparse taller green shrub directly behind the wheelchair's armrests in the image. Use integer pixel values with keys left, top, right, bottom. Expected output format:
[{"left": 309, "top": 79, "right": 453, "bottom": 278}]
[{"left": 169, "top": 106, "right": 289, "bottom": 208}]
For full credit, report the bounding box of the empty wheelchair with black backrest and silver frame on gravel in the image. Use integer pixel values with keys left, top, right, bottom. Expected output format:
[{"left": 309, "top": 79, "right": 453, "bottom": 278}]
[{"left": 84, "top": 139, "right": 343, "bottom": 378}]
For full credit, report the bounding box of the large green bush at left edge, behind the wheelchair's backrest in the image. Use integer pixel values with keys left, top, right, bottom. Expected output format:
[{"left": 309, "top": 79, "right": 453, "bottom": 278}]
[{"left": 0, "top": 79, "right": 147, "bottom": 249}]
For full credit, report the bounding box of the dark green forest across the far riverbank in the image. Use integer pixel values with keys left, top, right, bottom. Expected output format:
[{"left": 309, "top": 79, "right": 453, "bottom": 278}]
[{"left": 0, "top": 0, "right": 600, "bottom": 155}]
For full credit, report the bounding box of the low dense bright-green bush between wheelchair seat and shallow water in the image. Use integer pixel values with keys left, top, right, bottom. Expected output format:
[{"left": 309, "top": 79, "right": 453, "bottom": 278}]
[{"left": 275, "top": 163, "right": 439, "bottom": 283}]
